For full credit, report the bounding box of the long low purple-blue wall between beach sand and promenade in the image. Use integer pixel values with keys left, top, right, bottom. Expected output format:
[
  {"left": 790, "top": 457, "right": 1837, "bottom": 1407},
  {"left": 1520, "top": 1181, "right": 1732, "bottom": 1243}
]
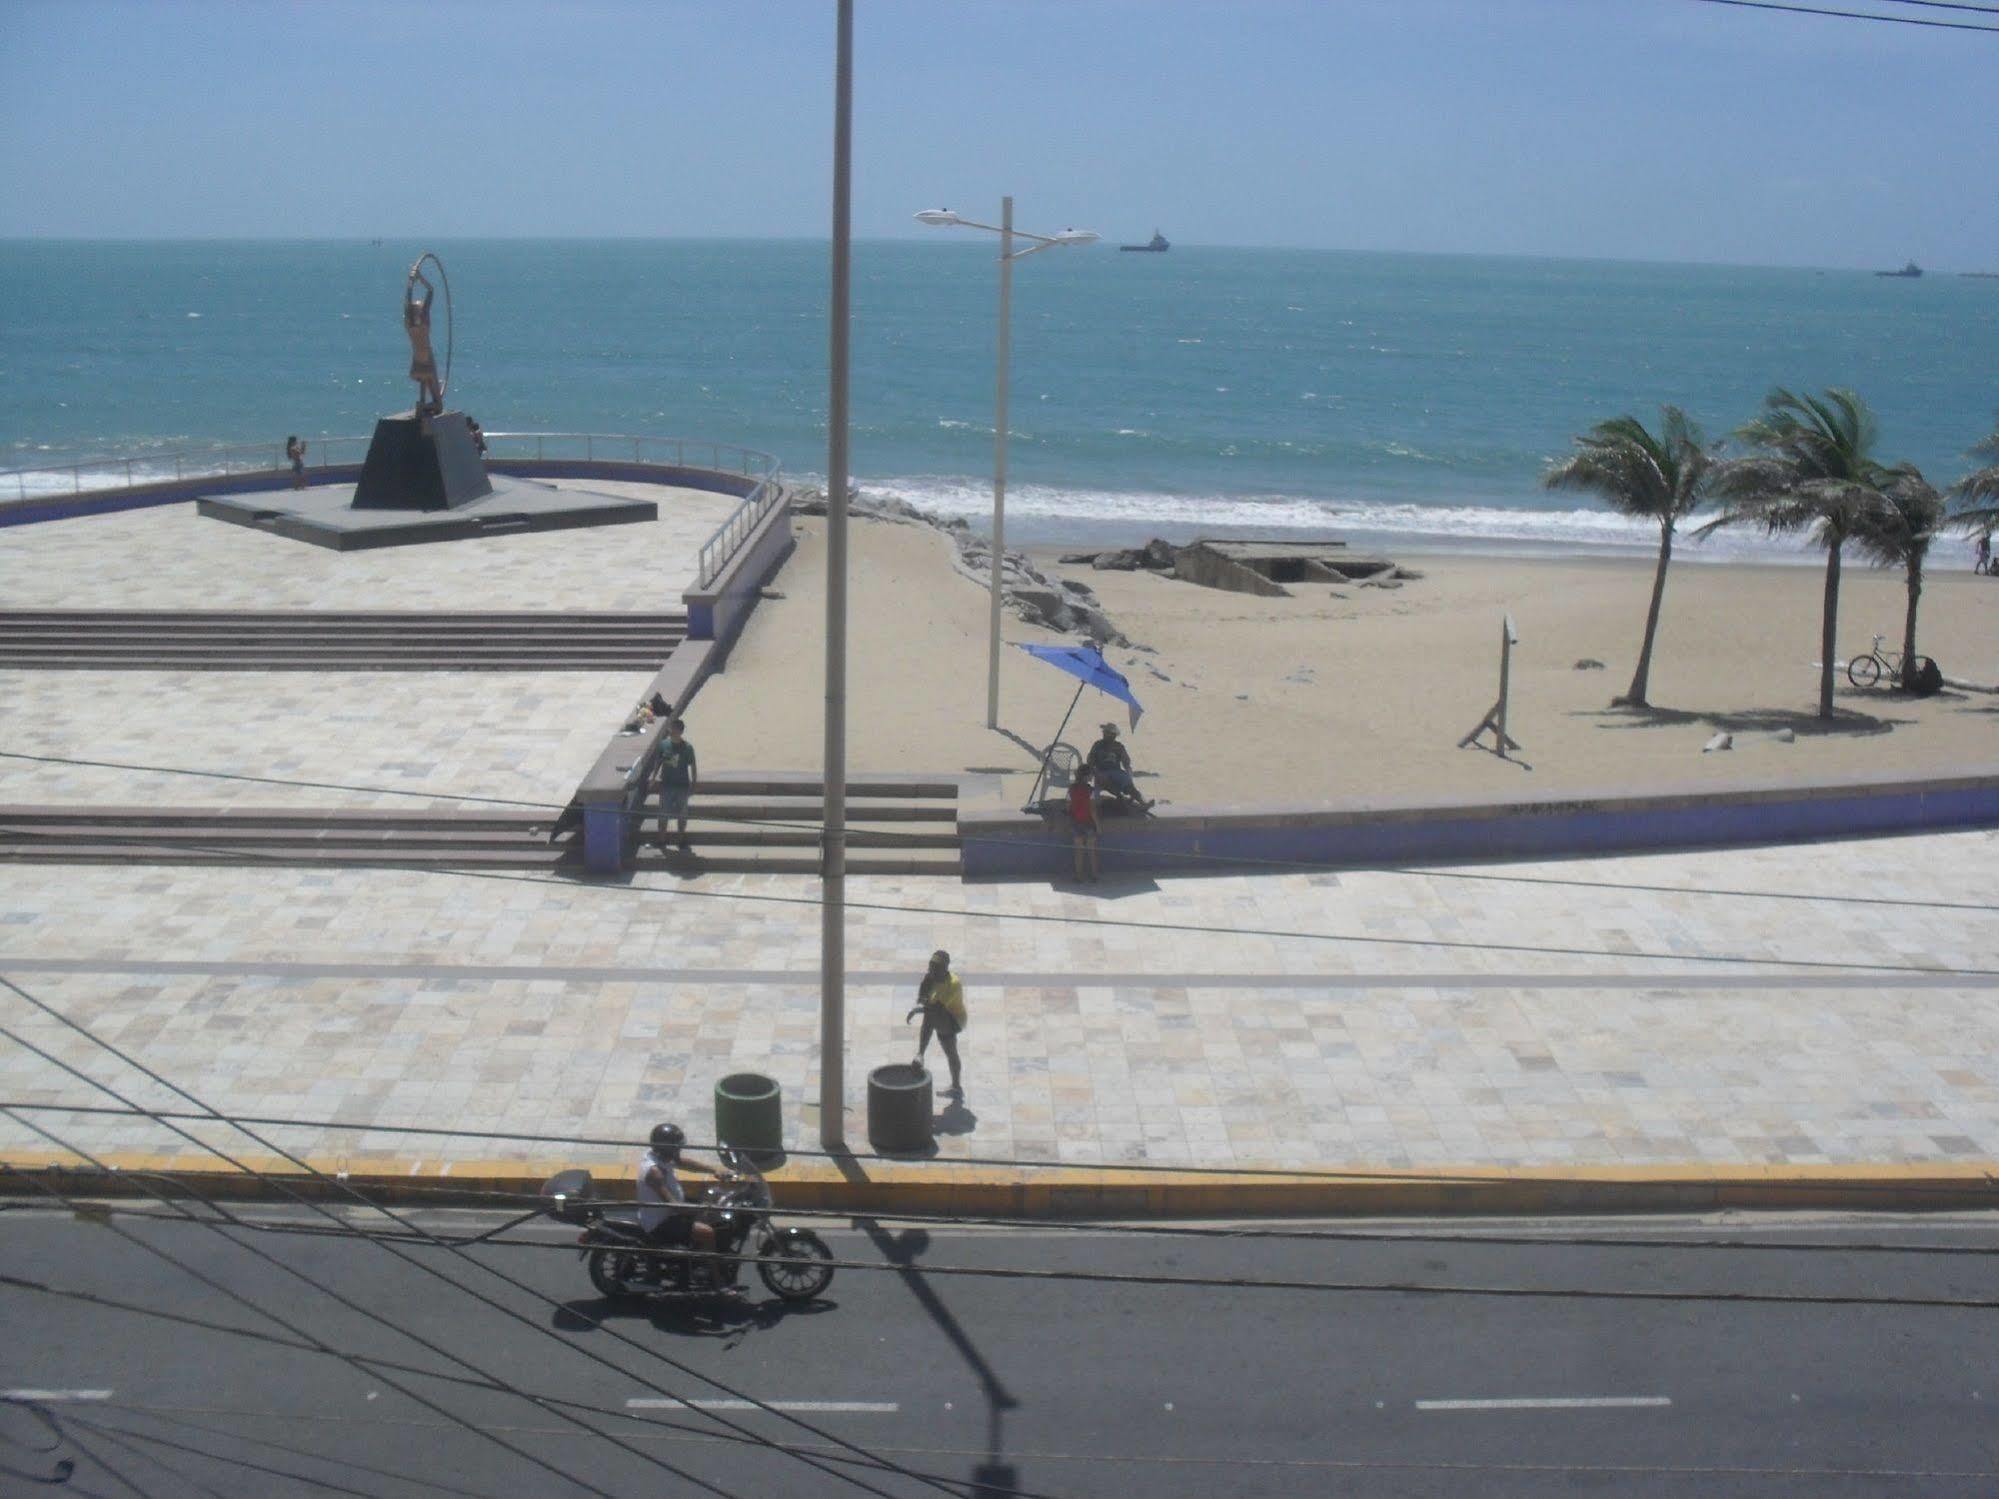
[{"left": 958, "top": 771, "right": 1999, "bottom": 879}]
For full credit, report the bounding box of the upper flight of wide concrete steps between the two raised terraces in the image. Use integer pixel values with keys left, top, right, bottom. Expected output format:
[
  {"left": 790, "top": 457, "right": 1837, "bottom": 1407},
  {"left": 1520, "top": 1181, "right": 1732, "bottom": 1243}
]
[{"left": 0, "top": 610, "right": 688, "bottom": 672}]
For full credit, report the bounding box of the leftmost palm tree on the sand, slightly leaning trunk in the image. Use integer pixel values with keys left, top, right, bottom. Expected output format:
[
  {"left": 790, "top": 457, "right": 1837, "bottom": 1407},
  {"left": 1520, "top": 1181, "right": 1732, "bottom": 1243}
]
[{"left": 1541, "top": 406, "right": 1715, "bottom": 708}]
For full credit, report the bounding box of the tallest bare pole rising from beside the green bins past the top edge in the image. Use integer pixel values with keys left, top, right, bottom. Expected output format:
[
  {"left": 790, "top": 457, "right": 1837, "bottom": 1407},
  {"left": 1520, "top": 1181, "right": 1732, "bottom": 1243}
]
[{"left": 820, "top": 0, "right": 854, "bottom": 1151}]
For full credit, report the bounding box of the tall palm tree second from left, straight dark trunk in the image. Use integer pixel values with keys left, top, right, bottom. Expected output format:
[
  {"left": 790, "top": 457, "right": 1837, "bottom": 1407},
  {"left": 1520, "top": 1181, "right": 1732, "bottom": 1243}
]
[{"left": 1699, "top": 388, "right": 1889, "bottom": 718}]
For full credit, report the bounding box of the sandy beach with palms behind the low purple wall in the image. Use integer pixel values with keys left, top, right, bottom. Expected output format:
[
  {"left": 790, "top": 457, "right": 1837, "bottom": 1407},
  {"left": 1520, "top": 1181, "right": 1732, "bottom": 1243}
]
[{"left": 690, "top": 520, "right": 1999, "bottom": 805}]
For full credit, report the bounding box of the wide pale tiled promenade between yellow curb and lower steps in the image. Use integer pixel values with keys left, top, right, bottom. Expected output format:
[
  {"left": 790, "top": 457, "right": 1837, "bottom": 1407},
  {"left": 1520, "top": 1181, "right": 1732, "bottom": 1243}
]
[{"left": 0, "top": 831, "right": 1999, "bottom": 1171}]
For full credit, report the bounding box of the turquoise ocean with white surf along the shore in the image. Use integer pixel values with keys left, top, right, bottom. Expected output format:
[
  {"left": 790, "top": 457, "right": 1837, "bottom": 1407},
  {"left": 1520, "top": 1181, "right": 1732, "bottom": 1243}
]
[{"left": 0, "top": 230, "right": 1999, "bottom": 560}]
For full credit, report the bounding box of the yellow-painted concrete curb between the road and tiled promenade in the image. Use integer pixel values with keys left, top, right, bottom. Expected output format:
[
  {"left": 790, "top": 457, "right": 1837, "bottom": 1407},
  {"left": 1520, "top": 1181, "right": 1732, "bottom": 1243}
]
[{"left": 0, "top": 1151, "right": 1999, "bottom": 1219}]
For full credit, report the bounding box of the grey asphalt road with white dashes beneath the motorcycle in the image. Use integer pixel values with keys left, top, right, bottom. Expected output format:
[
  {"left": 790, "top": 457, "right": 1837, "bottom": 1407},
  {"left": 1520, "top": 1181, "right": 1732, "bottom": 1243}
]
[{"left": 0, "top": 1209, "right": 1999, "bottom": 1499}]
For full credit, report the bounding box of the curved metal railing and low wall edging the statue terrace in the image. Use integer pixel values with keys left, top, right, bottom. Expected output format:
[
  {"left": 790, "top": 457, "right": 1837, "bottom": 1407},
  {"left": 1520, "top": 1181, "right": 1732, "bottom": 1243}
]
[{"left": 0, "top": 432, "right": 784, "bottom": 588}]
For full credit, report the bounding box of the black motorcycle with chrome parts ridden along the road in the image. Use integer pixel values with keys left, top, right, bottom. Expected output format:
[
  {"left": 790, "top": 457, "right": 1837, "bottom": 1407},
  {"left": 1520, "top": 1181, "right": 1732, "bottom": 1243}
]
[{"left": 542, "top": 1145, "right": 834, "bottom": 1301}]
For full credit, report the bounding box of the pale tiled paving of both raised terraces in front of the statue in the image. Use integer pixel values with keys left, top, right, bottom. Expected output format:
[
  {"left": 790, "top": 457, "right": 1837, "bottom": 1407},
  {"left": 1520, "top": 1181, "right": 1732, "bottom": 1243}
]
[{"left": 0, "top": 482, "right": 738, "bottom": 811}]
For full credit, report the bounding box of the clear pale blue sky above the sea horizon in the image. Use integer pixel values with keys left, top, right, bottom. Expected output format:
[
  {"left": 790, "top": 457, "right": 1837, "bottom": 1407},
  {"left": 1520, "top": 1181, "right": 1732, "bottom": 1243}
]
[{"left": 0, "top": 0, "right": 1999, "bottom": 270}]
